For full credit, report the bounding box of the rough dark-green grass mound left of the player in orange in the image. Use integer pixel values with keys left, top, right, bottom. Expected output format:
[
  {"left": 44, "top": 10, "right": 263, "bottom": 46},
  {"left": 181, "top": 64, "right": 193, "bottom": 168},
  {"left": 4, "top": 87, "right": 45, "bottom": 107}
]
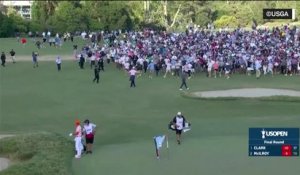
[{"left": 0, "top": 133, "right": 73, "bottom": 175}]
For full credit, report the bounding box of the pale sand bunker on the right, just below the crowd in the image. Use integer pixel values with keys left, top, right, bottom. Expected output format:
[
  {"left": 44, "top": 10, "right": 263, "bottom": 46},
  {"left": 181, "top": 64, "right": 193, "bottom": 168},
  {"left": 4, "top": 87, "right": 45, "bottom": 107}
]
[{"left": 192, "top": 88, "right": 300, "bottom": 98}]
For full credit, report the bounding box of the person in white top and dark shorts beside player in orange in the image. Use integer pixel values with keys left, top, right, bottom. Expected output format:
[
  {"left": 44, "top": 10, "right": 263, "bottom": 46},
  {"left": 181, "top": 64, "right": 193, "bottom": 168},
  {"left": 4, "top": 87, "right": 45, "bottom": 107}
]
[{"left": 83, "top": 119, "right": 96, "bottom": 154}]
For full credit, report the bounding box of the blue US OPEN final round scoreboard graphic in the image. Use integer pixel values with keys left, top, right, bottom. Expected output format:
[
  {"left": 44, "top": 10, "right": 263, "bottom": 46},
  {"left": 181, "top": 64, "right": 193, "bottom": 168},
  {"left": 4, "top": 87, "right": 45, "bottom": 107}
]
[{"left": 249, "top": 128, "right": 299, "bottom": 157}]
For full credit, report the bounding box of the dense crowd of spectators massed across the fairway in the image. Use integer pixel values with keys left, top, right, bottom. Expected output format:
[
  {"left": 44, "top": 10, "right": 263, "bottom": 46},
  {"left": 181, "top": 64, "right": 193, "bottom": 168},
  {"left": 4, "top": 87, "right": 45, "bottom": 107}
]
[{"left": 74, "top": 26, "right": 300, "bottom": 78}]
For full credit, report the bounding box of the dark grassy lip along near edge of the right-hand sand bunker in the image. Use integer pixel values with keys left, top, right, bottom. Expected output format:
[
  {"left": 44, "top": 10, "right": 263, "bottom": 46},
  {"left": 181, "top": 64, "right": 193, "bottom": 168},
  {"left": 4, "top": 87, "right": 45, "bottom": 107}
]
[{"left": 181, "top": 92, "right": 300, "bottom": 103}]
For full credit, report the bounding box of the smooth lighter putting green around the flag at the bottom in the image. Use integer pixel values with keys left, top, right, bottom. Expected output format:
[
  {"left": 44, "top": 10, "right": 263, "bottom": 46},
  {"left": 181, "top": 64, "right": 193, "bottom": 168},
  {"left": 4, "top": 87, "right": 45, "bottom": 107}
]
[{"left": 73, "top": 136, "right": 300, "bottom": 175}]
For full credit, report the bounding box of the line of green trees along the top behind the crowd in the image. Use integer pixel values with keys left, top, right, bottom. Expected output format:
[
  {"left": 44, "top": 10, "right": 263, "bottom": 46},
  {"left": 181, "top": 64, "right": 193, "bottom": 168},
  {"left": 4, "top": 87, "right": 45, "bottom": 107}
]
[{"left": 0, "top": 0, "right": 300, "bottom": 37}]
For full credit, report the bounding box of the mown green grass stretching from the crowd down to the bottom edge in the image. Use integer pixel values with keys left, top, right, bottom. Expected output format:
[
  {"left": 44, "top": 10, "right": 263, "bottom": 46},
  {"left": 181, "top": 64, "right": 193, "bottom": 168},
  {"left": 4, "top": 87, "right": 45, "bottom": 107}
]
[{"left": 0, "top": 61, "right": 300, "bottom": 175}]
